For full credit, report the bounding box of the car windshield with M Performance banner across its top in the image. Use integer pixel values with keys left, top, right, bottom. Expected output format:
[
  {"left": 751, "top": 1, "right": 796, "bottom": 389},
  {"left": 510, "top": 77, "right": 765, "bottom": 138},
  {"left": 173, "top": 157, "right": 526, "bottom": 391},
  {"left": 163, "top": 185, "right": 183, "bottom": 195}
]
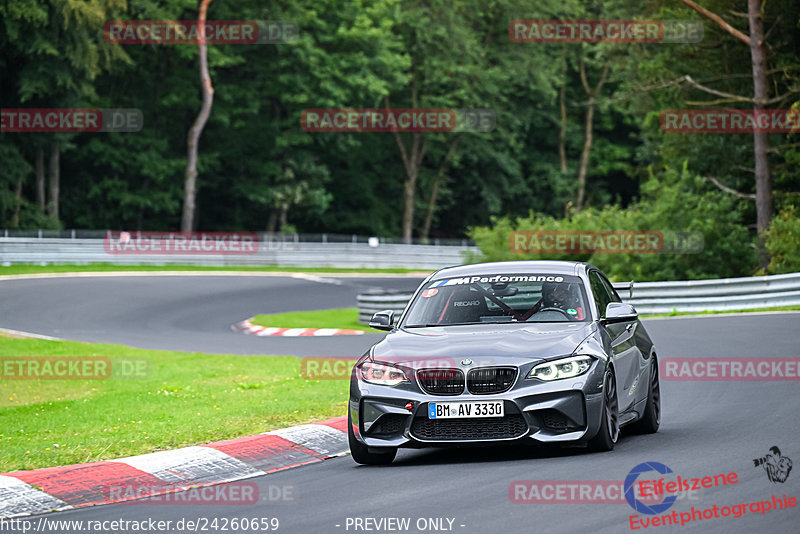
[{"left": 403, "top": 273, "right": 589, "bottom": 328}]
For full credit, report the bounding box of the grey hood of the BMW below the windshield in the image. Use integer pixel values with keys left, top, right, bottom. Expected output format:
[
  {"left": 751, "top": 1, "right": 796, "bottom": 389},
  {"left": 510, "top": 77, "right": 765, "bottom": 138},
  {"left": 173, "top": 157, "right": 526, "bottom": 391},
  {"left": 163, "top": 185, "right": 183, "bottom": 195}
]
[{"left": 373, "top": 323, "right": 595, "bottom": 367}]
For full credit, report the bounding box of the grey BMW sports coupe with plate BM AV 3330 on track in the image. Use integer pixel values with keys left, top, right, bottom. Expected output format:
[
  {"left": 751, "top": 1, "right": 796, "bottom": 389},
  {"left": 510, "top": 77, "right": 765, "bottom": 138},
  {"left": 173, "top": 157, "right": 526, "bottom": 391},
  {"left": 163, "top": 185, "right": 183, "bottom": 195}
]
[{"left": 348, "top": 261, "right": 661, "bottom": 464}]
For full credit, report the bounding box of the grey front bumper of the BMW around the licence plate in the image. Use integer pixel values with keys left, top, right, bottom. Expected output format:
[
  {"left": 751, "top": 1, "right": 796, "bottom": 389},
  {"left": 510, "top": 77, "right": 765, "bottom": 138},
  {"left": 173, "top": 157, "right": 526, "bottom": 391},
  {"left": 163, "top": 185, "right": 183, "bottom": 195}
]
[{"left": 349, "top": 360, "right": 605, "bottom": 447}]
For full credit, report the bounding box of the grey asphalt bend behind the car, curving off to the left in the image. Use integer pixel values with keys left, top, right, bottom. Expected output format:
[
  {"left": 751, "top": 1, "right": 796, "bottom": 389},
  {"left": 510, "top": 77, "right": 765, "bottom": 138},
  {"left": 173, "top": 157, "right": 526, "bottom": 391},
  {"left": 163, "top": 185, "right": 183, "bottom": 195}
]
[{"left": 0, "top": 276, "right": 422, "bottom": 356}]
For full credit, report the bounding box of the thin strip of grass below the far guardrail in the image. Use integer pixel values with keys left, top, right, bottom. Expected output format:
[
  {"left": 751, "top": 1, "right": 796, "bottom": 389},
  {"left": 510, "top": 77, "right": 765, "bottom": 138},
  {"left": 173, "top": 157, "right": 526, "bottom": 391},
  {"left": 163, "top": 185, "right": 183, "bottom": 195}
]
[{"left": 0, "top": 263, "right": 419, "bottom": 276}]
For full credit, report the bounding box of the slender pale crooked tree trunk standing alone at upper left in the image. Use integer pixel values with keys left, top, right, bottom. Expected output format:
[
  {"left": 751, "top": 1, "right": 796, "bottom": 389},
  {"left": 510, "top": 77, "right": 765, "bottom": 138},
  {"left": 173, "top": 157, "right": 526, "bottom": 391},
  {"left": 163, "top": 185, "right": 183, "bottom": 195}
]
[{"left": 181, "top": 0, "right": 214, "bottom": 232}]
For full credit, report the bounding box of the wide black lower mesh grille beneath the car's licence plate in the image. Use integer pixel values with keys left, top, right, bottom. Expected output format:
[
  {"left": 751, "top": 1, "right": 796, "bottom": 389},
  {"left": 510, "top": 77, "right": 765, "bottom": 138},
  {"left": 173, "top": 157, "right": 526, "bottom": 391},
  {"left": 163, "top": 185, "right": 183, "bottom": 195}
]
[{"left": 411, "top": 414, "right": 528, "bottom": 441}]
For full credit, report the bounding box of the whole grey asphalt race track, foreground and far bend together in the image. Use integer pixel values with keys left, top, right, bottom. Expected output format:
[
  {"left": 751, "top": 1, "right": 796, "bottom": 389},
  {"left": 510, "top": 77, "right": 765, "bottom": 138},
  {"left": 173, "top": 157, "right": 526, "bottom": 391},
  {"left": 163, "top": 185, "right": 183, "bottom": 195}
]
[{"left": 0, "top": 277, "right": 800, "bottom": 534}]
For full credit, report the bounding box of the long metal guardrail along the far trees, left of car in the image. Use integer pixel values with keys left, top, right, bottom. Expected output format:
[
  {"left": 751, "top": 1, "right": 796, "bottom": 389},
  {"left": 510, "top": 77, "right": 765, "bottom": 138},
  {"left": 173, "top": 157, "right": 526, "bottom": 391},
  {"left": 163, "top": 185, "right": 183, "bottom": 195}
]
[{"left": 0, "top": 239, "right": 478, "bottom": 270}]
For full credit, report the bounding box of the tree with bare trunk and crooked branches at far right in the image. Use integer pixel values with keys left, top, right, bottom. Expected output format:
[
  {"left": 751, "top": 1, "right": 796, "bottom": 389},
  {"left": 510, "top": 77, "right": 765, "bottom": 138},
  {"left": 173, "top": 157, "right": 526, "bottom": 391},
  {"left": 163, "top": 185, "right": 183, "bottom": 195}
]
[{"left": 622, "top": 0, "right": 800, "bottom": 266}]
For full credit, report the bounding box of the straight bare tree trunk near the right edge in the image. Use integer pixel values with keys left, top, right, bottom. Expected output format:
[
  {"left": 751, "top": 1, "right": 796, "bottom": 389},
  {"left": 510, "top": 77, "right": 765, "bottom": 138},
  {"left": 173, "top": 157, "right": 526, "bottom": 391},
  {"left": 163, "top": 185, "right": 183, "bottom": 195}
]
[{"left": 747, "top": 0, "right": 772, "bottom": 238}]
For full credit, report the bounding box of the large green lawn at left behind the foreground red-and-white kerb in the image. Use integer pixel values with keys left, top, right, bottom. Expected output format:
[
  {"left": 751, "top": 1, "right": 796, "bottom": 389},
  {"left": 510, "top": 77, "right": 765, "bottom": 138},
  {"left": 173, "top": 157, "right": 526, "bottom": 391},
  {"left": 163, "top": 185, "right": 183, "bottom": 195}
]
[{"left": 0, "top": 335, "right": 349, "bottom": 472}]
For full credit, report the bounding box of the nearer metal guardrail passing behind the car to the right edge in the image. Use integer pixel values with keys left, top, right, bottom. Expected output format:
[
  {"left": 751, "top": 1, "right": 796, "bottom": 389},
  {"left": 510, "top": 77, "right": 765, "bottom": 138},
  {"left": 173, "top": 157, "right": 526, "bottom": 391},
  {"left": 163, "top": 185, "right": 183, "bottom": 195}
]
[{"left": 358, "top": 273, "right": 800, "bottom": 324}]
